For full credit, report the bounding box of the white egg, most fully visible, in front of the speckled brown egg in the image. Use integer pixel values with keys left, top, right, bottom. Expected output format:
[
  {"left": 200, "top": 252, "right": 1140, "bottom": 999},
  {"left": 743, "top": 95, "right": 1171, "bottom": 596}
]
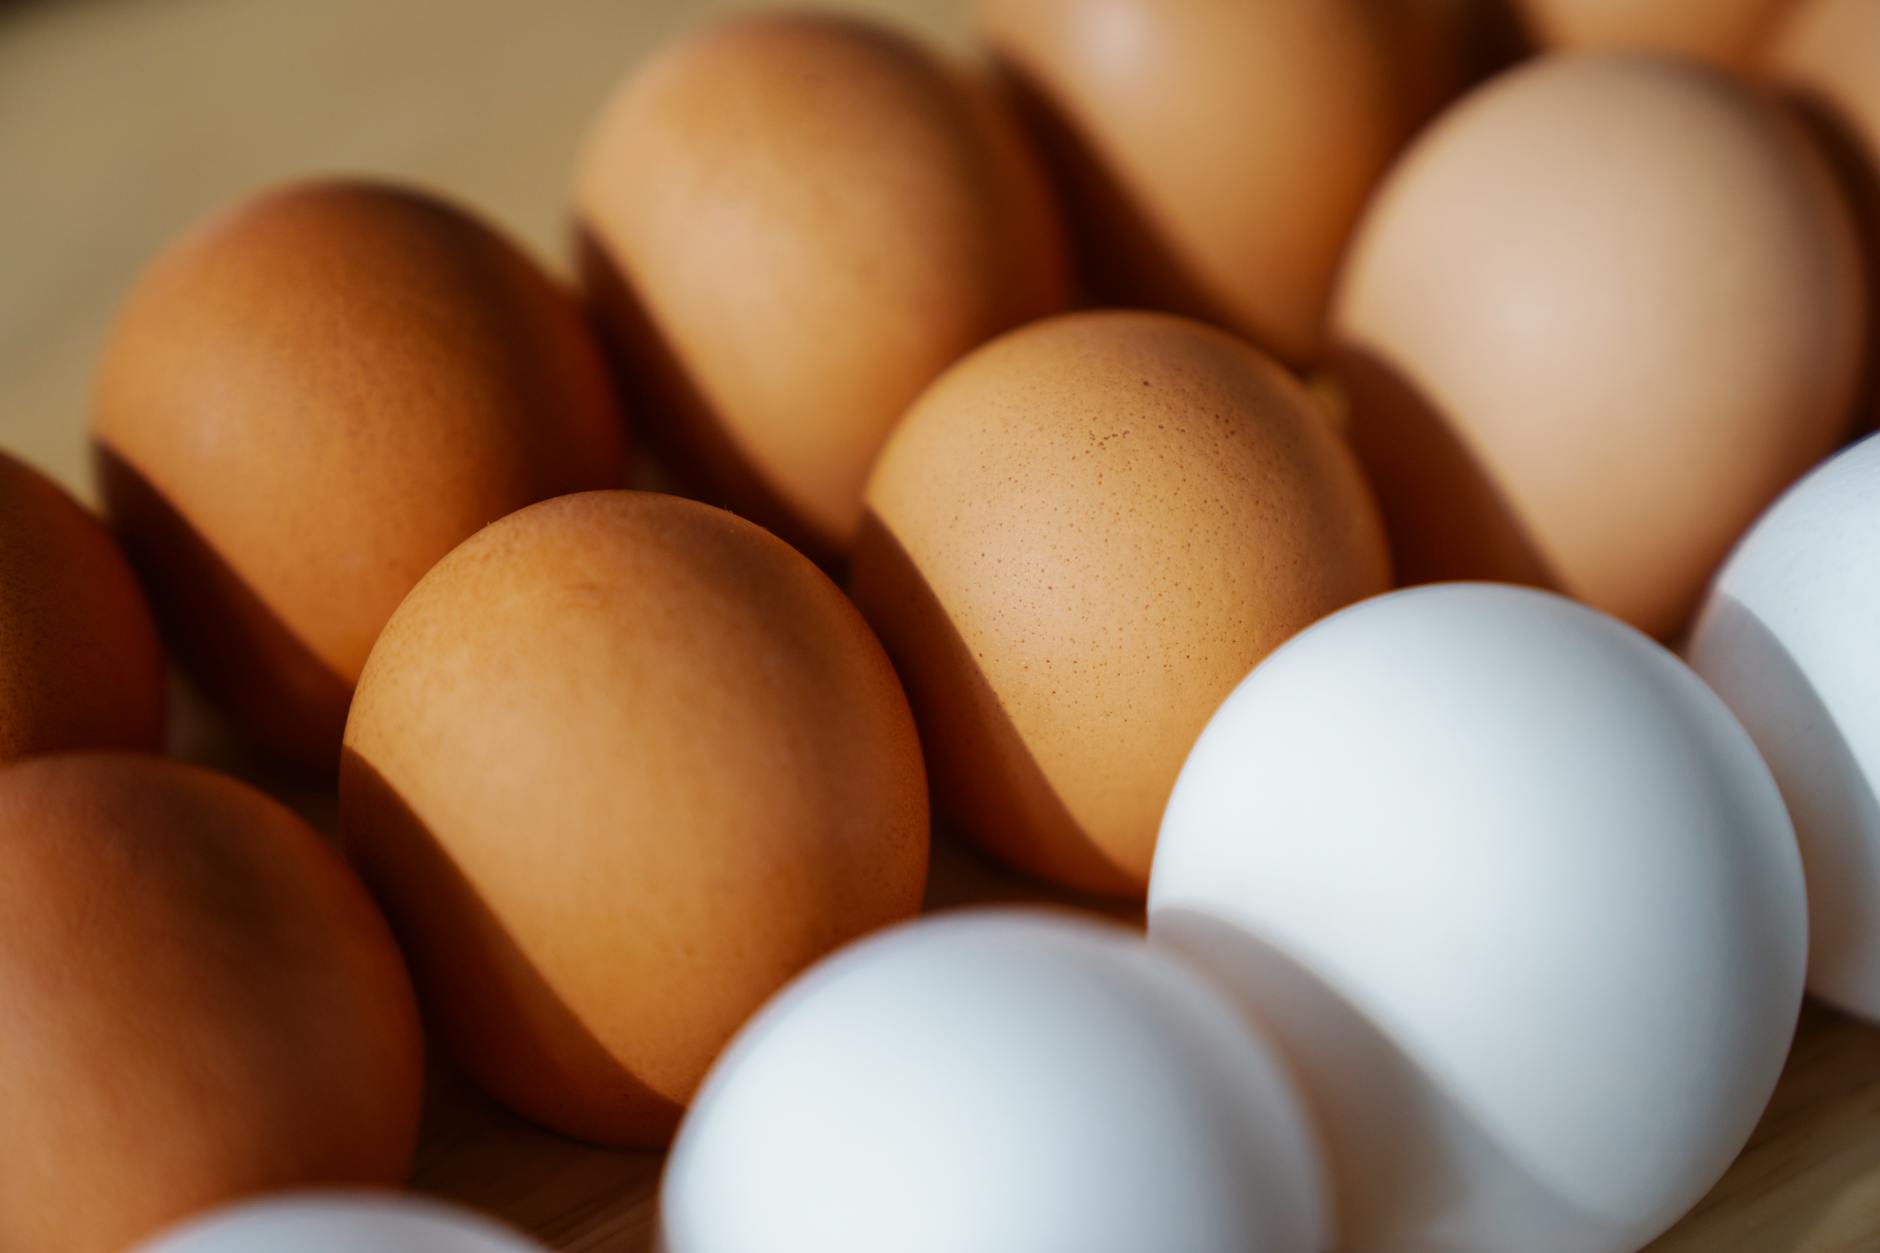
[{"left": 1149, "top": 583, "right": 1807, "bottom": 1253}]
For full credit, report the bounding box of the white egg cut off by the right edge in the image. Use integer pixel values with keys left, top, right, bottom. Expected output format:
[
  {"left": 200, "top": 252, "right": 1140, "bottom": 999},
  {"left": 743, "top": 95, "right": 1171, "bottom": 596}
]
[{"left": 1686, "top": 435, "right": 1880, "bottom": 1020}]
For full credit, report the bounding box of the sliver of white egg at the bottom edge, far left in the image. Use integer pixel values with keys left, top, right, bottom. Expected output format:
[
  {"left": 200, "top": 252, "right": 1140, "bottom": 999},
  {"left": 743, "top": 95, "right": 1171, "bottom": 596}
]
[{"left": 133, "top": 1193, "right": 547, "bottom": 1253}]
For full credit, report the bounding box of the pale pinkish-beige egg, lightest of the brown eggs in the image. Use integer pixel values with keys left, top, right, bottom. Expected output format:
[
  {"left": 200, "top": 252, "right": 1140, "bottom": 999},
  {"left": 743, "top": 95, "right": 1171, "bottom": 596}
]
[{"left": 1335, "top": 55, "right": 1865, "bottom": 636}]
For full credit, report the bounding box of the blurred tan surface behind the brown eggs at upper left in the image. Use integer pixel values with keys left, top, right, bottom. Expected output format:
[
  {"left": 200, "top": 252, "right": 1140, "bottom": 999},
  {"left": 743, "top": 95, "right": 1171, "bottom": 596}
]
[{"left": 0, "top": 0, "right": 970, "bottom": 499}]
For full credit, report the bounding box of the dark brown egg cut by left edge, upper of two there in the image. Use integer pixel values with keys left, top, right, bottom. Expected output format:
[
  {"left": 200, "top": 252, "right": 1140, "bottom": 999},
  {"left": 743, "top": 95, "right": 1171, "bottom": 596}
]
[{"left": 0, "top": 453, "right": 165, "bottom": 762}]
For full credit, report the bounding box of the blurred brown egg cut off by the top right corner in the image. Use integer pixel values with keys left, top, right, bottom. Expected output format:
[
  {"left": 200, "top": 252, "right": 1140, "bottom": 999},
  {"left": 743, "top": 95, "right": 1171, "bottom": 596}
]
[{"left": 1763, "top": 0, "right": 1880, "bottom": 427}]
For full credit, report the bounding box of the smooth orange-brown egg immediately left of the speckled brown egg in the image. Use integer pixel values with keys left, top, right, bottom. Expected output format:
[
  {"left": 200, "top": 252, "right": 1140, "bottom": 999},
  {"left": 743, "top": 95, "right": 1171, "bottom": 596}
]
[{"left": 340, "top": 491, "right": 927, "bottom": 1144}]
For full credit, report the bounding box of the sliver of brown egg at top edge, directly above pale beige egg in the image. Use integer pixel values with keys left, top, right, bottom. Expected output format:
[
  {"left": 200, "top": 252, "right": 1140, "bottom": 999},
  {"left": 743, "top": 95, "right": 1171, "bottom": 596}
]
[{"left": 1515, "top": 0, "right": 1794, "bottom": 70}]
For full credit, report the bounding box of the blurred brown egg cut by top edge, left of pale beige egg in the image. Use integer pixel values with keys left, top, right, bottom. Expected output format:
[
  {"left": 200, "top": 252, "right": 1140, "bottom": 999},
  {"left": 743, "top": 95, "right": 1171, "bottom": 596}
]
[{"left": 979, "top": 0, "right": 1465, "bottom": 361}]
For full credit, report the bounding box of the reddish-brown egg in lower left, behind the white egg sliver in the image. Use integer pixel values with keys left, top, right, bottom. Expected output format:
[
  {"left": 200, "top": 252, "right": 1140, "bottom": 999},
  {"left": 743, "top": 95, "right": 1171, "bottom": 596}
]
[{"left": 0, "top": 754, "right": 423, "bottom": 1253}]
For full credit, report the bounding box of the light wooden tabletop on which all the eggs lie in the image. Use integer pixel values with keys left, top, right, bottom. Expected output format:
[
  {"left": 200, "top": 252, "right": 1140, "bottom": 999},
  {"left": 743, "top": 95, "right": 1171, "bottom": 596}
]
[{"left": 0, "top": 0, "right": 1880, "bottom": 1253}]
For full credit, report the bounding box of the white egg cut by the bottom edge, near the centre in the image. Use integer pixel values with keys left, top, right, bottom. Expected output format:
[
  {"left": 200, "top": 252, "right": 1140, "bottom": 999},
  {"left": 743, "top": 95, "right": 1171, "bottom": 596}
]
[{"left": 660, "top": 911, "right": 1324, "bottom": 1253}]
